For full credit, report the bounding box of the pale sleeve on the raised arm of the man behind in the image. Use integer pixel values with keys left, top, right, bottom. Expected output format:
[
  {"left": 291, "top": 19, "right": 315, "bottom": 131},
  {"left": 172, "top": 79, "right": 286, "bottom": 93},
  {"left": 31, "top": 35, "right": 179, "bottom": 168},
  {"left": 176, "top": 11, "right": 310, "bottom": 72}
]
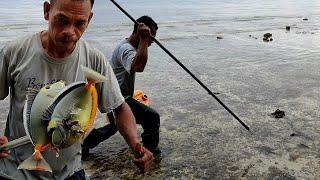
[{"left": 119, "top": 44, "right": 136, "bottom": 74}]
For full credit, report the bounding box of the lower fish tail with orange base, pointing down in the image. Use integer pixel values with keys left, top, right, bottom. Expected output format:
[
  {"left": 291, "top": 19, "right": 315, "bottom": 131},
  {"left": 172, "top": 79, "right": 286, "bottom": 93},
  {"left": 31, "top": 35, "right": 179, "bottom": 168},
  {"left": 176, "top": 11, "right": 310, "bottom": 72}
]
[{"left": 18, "top": 145, "right": 52, "bottom": 172}]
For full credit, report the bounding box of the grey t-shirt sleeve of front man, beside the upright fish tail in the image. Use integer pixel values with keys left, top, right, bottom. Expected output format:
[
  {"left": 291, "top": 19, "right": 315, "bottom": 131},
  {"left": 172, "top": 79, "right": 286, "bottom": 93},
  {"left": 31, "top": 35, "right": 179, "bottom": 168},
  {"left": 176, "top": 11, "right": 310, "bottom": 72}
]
[{"left": 92, "top": 52, "right": 124, "bottom": 113}]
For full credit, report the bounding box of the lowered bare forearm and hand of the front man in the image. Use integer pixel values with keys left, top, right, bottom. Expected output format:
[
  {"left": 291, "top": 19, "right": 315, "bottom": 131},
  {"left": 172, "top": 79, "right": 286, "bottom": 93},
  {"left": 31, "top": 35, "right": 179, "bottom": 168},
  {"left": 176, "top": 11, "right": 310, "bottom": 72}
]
[{"left": 115, "top": 102, "right": 153, "bottom": 172}]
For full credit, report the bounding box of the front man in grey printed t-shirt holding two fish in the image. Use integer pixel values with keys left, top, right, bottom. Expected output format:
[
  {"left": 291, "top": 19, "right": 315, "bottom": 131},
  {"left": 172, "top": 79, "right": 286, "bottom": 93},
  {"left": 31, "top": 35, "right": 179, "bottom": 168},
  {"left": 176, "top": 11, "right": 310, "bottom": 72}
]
[{"left": 0, "top": 0, "right": 152, "bottom": 179}]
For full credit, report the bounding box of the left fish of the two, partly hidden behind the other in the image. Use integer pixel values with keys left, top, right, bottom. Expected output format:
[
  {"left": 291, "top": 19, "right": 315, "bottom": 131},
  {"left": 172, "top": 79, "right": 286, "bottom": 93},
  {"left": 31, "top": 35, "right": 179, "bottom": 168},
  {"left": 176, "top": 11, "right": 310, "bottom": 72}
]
[{"left": 18, "top": 81, "right": 65, "bottom": 172}]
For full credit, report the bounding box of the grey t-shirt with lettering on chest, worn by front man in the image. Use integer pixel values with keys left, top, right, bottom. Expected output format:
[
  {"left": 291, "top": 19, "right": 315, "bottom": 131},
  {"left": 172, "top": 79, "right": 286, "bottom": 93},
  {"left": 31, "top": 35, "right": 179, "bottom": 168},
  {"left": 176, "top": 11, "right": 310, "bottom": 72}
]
[{"left": 0, "top": 33, "right": 124, "bottom": 179}]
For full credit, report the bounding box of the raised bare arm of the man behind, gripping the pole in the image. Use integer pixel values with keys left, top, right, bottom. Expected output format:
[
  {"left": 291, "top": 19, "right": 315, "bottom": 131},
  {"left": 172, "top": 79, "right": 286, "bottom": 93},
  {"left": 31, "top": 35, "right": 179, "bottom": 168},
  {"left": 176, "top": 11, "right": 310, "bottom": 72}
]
[{"left": 131, "top": 23, "right": 150, "bottom": 72}]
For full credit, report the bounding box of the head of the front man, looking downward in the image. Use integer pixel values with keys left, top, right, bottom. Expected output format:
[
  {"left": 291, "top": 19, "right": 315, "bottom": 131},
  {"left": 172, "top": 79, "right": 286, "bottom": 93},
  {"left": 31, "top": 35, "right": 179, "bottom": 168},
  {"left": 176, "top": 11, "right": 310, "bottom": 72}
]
[{"left": 44, "top": 0, "right": 93, "bottom": 50}]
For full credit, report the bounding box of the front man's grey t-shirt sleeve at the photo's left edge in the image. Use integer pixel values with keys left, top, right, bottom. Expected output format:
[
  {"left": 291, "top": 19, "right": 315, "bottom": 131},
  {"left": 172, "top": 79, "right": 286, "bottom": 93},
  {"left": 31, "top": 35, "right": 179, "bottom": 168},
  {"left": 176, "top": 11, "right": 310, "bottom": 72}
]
[{"left": 0, "top": 48, "right": 9, "bottom": 100}]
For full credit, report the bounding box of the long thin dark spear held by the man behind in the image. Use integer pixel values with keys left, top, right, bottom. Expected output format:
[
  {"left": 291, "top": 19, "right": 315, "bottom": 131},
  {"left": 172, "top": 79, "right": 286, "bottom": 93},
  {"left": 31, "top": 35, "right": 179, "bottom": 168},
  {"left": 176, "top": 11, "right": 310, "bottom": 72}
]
[{"left": 110, "top": 0, "right": 250, "bottom": 131}]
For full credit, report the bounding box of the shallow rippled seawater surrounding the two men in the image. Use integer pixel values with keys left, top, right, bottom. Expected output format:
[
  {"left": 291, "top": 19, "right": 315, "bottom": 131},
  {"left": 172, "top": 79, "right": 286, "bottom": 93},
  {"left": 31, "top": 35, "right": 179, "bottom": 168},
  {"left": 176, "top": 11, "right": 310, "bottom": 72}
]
[{"left": 0, "top": 0, "right": 320, "bottom": 179}]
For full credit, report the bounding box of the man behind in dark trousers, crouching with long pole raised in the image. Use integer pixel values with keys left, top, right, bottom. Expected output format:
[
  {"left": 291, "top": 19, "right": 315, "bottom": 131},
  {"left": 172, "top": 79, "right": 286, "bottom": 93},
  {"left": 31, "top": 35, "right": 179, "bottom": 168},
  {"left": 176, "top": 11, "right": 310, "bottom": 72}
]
[{"left": 83, "top": 16, "right": 161, "bottom": 156}]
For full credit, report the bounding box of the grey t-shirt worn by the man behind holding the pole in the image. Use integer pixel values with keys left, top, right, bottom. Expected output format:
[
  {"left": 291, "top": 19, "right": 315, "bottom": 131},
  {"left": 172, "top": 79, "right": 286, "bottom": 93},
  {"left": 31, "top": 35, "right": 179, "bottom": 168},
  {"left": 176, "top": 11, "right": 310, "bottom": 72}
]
[{"left": 110, "top": 39, "right": 137, "bottom": 98}]
